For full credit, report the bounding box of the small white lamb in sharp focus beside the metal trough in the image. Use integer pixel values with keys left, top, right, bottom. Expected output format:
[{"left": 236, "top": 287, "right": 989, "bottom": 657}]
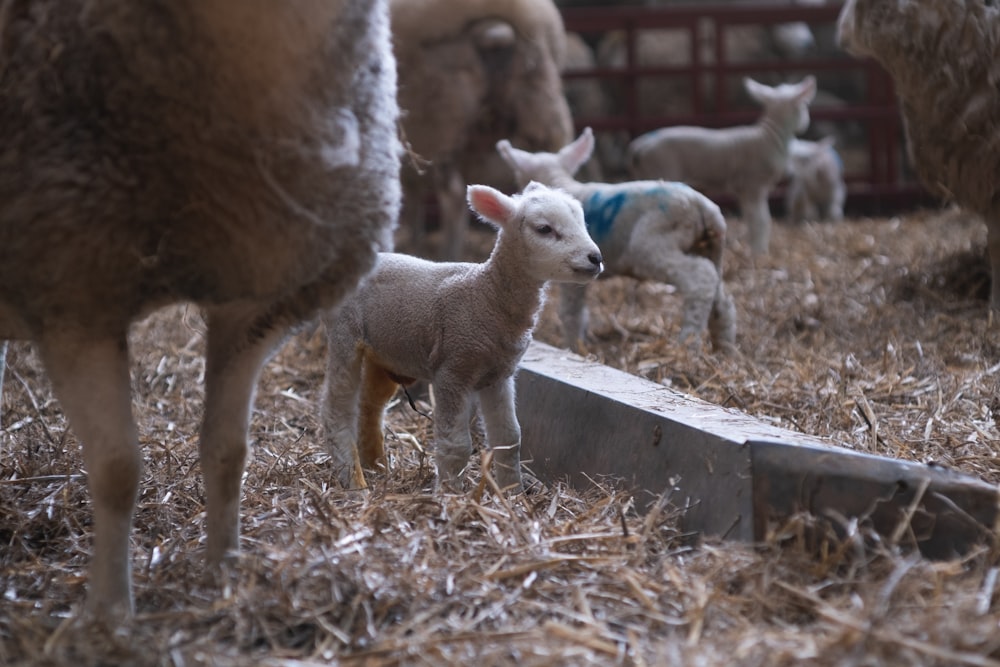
[{"left": 321, "top": 184, "right": 603, "bottom": 491}]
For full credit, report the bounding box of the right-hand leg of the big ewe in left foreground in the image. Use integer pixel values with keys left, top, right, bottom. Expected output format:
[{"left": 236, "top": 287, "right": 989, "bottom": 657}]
[{"left": 199, "top": 306, "right": 287, "bottom": 570}]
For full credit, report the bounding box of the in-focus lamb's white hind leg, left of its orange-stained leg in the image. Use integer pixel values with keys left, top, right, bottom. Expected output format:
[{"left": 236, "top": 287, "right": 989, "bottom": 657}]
[{"left": 320, "top": 320, "right": 367, "bottom": 489}]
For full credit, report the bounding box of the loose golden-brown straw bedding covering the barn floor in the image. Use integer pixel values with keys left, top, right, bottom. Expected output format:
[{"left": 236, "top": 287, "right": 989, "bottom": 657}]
[{"left": 0, "top": 206, "right": 1000, "bottom": 667}]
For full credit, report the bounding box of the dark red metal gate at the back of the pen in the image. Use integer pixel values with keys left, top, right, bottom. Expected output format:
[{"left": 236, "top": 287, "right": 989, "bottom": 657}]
[{"left": 562, "top": 4, "right": 934, "bottom": 215}]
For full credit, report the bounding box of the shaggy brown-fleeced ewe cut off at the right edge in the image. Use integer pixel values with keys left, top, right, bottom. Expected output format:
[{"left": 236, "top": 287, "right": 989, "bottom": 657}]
[{"left": 837, "top": 0, "right": 1000, "bottom": 312}]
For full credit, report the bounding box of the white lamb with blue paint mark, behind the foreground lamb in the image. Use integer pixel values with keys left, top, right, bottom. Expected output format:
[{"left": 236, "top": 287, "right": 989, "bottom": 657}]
[{"left": 497, "top": 127, "right": 736, "bottom": 352}]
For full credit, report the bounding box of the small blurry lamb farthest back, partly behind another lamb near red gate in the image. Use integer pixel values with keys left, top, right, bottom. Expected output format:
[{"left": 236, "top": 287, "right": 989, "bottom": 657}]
[{"left": 785, "top": 136, "right": 847, "bottom": 223}]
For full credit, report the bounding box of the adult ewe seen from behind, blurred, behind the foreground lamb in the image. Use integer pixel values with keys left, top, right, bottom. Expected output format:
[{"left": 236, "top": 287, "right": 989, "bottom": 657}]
[{"left": 391, "top": 0, "right": 573, "bottom": 259}]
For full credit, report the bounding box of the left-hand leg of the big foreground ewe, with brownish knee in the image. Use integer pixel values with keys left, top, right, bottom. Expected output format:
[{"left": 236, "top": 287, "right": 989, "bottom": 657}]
[{"left": 39, "top": 333, "right": 142, "bottom": 623}]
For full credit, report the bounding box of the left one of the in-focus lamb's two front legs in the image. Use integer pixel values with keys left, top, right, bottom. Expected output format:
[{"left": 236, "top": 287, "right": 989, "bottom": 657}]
[{"left": 434, "top": 382, "right": 472, "bottom": 492}]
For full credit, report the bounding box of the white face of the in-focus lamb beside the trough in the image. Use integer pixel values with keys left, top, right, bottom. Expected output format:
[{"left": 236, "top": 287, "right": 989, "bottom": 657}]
[{"left": 519, "top": 184, "right": 604, "bottom": 283}]
